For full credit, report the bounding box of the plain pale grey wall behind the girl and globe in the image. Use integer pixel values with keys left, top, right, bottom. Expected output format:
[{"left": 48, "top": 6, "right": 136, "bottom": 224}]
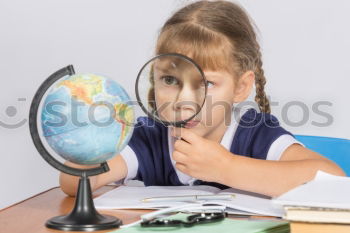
[{"left": 0, "top": 0, "right": 350, "bottom": 209}]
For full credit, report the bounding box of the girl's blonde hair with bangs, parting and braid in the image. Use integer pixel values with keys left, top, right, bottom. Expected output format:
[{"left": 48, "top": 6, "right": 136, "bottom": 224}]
[{"left": 149, "top": 1, "right": 271, "bottom": 113}]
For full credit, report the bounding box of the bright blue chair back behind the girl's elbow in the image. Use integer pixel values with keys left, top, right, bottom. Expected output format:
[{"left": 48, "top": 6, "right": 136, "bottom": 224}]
[{"left": 295, "top": 135, "right": 350, "bottom": 176}]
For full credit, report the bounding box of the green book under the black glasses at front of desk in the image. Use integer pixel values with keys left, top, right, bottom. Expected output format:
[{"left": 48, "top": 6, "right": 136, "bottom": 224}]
[{"left": 110, "top": 213, "right": 290, "bottom": 233}]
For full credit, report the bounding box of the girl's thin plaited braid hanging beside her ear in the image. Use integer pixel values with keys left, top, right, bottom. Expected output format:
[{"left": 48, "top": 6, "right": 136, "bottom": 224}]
[{"left": 255, "top": 56, "right": 271, "bottom": 113}]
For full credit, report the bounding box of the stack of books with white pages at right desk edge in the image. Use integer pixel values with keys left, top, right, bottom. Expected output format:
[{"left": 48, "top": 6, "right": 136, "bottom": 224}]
[{"left": 273, "top": 171, "right": 350, "bottom": 233}]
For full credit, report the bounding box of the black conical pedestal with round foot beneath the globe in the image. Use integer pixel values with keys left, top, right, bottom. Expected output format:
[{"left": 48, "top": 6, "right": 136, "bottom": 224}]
[{"left": 46, "top": 173, "right": 122, "bottom": 231}]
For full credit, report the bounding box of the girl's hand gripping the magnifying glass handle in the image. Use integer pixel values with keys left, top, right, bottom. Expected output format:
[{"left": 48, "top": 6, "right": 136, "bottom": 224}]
[{"left": 172, "top": 128, "right": 232, "bottom": 182}]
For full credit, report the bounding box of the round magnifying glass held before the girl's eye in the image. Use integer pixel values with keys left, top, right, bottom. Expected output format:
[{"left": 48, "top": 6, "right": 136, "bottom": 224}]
[{"left": 135, "top": 53, "right": 207, "bottom": 137}]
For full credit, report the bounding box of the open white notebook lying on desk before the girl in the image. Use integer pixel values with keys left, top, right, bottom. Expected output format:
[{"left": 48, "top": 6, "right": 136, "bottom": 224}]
[{"left": 94, "top": 185, "right": 283, "bottom": 217}]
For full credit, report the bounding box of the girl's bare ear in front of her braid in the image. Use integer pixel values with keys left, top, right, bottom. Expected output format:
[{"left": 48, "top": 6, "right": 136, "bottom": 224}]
[{"left": 233, "top": 70, "right": 255, "bottom": 103}]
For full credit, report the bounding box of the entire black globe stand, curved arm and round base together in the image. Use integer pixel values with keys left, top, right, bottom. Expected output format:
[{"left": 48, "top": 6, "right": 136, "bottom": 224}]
[{"left": 29, "top": 65, "right": 122, "bottom": 231}]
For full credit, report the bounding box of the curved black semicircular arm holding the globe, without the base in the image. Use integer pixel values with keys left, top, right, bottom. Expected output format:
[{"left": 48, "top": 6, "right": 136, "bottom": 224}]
[{"left": 29, "top": 65, "right": 109, "bottom": 177}]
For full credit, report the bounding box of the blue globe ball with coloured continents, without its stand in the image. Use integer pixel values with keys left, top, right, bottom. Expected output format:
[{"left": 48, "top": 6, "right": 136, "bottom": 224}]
[{"left": 39, "top": 74, "right": 134, "bottom": 165}]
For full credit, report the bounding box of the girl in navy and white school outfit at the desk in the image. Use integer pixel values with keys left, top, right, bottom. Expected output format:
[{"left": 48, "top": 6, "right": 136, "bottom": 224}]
[{"left": 60, "top": 1, "right": 344, "bottom": 196}]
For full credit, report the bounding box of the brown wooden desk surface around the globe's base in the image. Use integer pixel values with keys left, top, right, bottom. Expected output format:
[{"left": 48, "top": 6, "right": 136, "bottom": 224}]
[{"left": 0, "top": 186, "right": 149, "bottom": 233}]
